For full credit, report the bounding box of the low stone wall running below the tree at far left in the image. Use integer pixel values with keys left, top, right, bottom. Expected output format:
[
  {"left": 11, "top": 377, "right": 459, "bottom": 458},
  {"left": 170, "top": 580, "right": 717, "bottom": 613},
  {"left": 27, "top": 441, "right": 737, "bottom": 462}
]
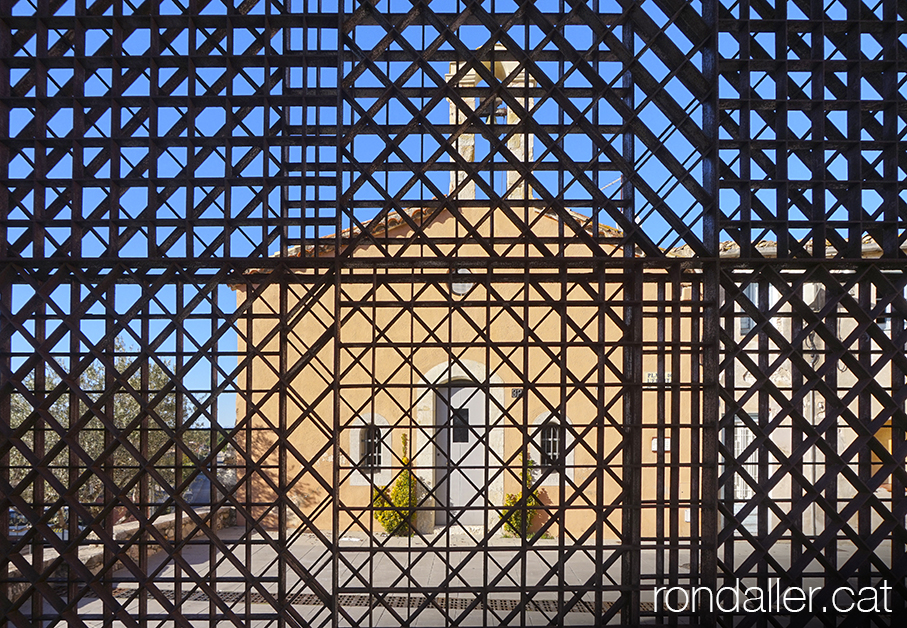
[{"left": 7, "top": 508, "right": 233, "bottom": 602}]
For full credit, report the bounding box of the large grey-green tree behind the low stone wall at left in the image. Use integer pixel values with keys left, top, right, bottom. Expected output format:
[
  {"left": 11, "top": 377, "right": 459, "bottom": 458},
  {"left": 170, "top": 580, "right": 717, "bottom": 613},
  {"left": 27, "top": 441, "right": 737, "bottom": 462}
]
[{"left": 8, "top": 340, "right": 196, "bottom": 523}]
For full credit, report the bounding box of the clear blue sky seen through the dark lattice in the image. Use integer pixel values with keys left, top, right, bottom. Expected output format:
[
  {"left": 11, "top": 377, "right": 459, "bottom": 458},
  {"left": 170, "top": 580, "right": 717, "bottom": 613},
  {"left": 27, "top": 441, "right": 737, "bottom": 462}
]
[{"left": 8, "top": 0, "right": 907, "bottom": 430}]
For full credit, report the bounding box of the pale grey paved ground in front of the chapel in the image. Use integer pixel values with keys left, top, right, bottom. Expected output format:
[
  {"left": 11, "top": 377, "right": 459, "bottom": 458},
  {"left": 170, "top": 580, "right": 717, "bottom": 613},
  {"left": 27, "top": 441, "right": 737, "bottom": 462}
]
[{"left": 33, "top": 527, "right": 864, "bottom": 627}]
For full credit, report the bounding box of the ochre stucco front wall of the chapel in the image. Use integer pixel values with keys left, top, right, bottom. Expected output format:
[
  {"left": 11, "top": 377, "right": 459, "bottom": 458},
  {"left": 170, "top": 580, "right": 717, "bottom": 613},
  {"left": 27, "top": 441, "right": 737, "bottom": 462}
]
[{"left": 237, "top": 209, "right": 698, "bottom": 536}]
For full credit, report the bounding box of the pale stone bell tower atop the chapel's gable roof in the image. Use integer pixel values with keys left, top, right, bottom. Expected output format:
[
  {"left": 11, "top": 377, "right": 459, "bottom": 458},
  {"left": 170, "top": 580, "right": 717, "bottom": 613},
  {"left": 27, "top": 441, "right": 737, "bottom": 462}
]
[{"left": 446, "top": 44, "right": 535, "bottom": 200}]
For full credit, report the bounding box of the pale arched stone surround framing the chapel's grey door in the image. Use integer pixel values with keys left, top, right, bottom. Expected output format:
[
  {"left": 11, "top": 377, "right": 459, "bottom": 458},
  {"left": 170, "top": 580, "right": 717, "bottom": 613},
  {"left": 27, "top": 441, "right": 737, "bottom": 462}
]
[{"left": 413, "top": 360, "right": 504, "bottom": 533}]
